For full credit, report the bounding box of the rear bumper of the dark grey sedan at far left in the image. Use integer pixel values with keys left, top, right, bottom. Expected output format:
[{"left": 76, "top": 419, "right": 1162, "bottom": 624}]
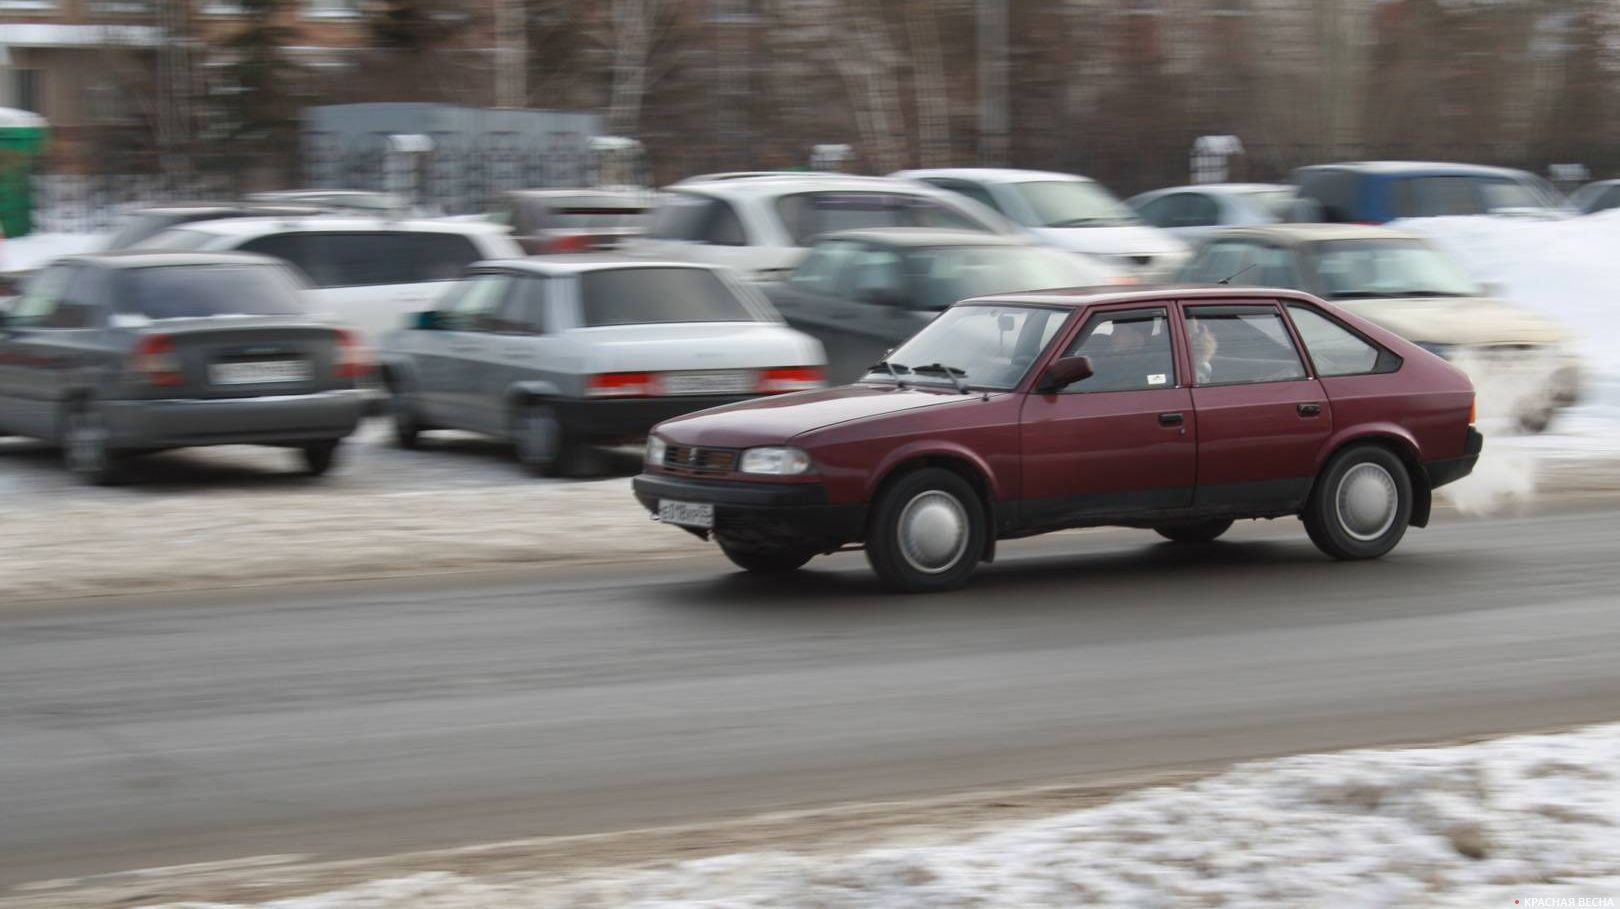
[{"left": 102, "top": 389, "right": 366, "bottom": 449}]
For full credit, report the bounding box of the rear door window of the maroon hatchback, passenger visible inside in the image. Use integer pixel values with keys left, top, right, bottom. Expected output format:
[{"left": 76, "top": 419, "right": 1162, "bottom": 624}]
[{"left": 1187, "top": 306, "right": 1306, "bottom": 386}]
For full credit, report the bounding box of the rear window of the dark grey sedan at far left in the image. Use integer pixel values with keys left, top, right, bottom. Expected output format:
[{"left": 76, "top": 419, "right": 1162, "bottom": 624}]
[{"left": 115, "top": 264, "right": 303, "bottom": 319}]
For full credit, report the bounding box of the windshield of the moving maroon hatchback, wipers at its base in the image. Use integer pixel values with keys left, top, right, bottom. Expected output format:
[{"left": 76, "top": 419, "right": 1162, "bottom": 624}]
[{"left": 860, "top": 303, "right": 1069, "bottom": 390}]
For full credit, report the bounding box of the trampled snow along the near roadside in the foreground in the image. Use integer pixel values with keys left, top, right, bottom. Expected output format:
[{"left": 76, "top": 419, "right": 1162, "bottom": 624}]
[{"left": 149, "top": 724, "right": 1620, "bottom": 909}]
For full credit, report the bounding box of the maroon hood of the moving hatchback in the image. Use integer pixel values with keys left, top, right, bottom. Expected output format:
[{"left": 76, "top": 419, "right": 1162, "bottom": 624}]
[{"left": 658, "top": 386, "right": 980, "bottom": 449}]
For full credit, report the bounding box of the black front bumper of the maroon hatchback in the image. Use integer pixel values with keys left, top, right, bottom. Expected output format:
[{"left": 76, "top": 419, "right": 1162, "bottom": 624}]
[{"left": 632, "top": 473, "right": 867, "bottom": 551}]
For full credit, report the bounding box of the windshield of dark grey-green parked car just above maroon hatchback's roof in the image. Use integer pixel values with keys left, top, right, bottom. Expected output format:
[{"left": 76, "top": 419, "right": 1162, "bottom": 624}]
[{"left": 906, "top": 246, "right": 1115, "bottom": 309}]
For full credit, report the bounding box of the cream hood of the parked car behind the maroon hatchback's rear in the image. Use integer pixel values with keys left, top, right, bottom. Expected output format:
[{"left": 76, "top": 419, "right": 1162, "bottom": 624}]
[{"left": 1333, "top": 297, "right": 1565, "bottom": 345}]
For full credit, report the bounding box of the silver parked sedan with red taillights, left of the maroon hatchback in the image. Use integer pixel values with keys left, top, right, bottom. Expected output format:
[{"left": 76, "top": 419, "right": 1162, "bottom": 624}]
[{"left": 381, "top": 256, "right": 826, "bottom": 476}]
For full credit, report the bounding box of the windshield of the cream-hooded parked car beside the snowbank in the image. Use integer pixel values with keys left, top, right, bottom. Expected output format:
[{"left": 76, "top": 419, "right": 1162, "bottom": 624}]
[{"left": 1315, "top": 240, "right": 1481, "bottom": 300}]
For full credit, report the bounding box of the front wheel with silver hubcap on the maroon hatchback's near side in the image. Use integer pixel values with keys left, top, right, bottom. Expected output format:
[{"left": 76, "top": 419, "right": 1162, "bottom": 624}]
[{"left": 867, "top": 467, "right": 990, "bottom": 593}]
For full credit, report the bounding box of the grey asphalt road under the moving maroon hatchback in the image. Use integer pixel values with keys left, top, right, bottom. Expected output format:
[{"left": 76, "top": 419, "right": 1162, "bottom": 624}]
[{"left": 0, "top": 510, "right": 1620, "bottom": 886}]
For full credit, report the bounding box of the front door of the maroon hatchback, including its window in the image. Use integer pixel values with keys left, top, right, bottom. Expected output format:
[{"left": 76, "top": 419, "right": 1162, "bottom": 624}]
[{"left": 1021, "top": 303, "right": 1199, "bottom": 528}]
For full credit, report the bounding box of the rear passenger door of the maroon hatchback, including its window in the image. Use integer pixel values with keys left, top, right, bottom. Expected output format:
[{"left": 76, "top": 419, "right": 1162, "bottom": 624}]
[{"left": 1183, "top": 300, "right": 1333, "bottom": 512}]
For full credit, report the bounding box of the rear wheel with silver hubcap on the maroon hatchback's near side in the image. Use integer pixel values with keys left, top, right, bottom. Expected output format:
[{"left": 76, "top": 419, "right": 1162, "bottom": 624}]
[{"left": 1302, "top": 446, "right": 1413, "bottom": 559}]
